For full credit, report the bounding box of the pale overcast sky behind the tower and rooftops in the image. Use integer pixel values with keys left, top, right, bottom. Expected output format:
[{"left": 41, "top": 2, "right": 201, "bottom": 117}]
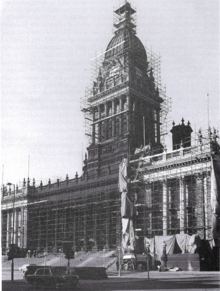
[{"left": 0, "top": 0, "right": 220, "bottom": 184}]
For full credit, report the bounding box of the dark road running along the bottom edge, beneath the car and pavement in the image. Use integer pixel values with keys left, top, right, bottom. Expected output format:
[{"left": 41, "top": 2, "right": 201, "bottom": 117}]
[{"left": 1, "top": 272, "right": 220, "bottom": 291}]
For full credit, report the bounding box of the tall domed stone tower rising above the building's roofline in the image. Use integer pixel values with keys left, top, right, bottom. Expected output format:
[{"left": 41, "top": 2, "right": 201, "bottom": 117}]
[{"left": 83, "top": 2, "right": 163, "bottom": 178}]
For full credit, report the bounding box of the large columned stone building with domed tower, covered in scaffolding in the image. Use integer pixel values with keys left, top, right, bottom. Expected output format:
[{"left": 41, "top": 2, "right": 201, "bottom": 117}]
[{"left": 1, "top": 2, "right": 220, "bottom": 270}]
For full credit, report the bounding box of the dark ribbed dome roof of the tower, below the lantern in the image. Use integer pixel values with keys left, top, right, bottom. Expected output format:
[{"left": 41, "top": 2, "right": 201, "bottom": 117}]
[{"left": 105, "top": 27, "right": 147, "bottom": 60}]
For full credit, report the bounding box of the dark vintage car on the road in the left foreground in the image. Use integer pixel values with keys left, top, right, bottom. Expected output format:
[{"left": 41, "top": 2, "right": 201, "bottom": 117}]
[{"left": 26, "top": 267, "right": 79, "bottom": 289}]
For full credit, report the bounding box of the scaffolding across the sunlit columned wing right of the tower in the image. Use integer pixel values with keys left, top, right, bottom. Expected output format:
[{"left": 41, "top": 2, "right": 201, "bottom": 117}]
[{"left": 130, "top": 129, "right": 219, "bottom": 250}]
